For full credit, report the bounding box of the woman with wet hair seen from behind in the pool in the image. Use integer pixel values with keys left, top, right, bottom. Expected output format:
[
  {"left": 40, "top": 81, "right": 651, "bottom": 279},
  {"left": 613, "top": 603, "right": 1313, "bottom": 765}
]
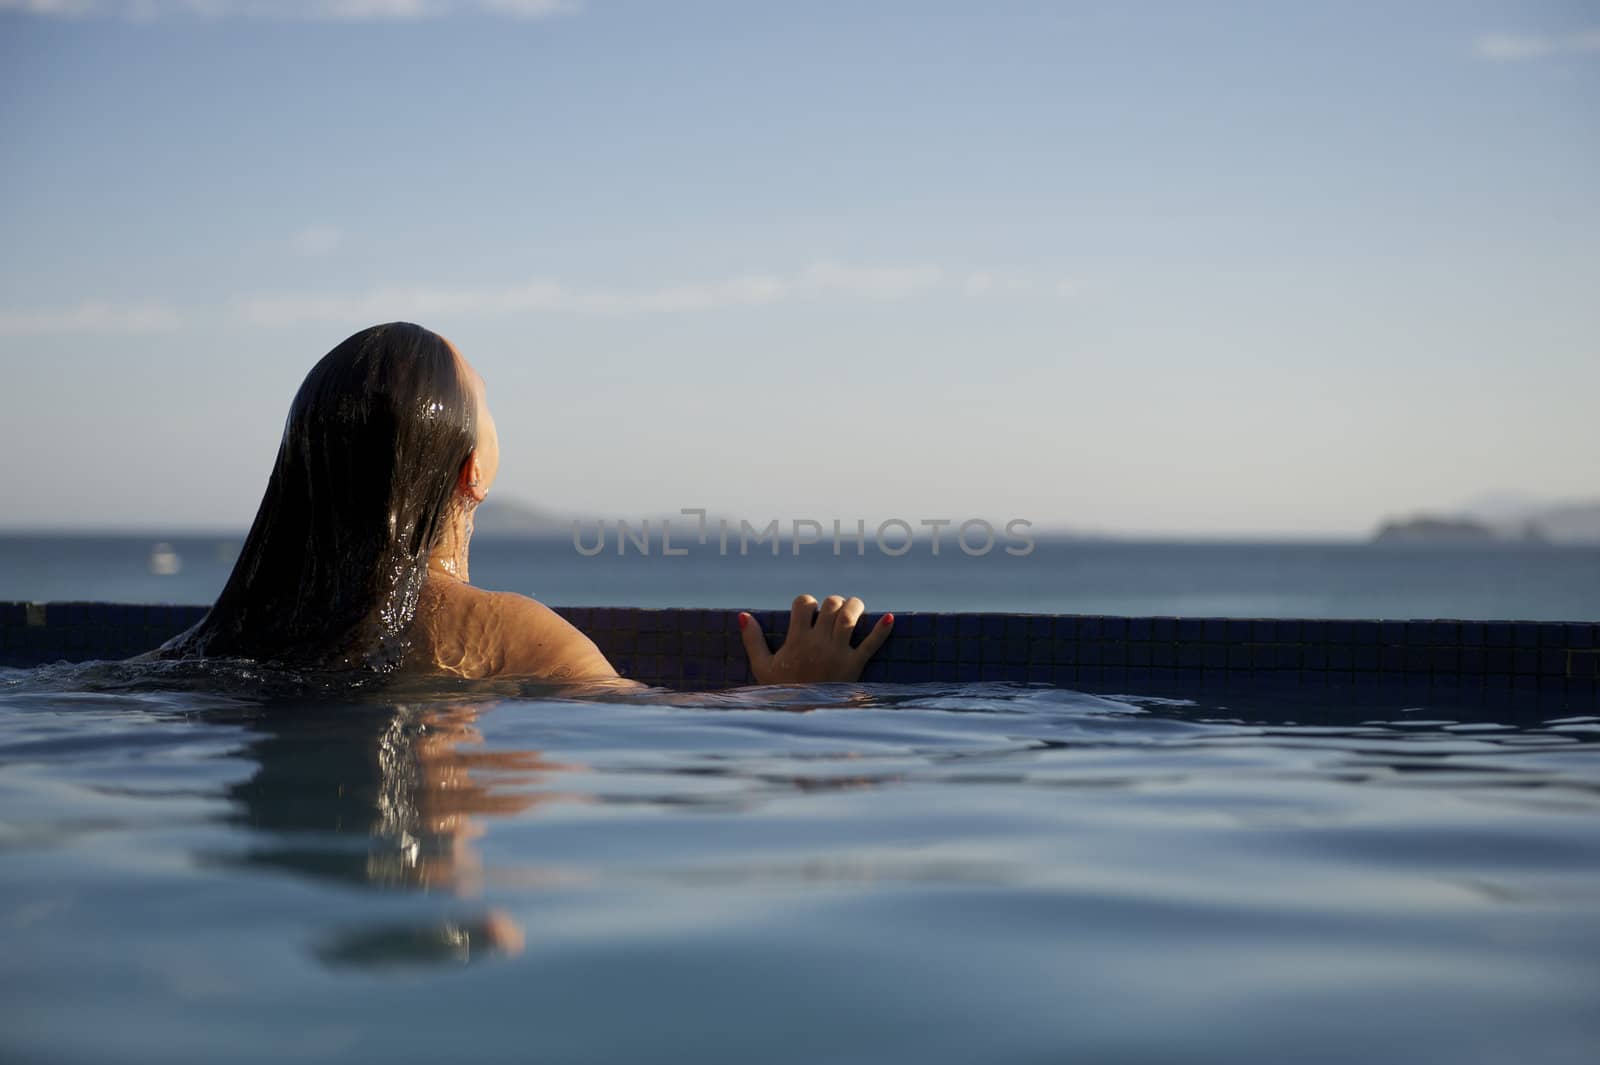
[{"left": 162, "top": 323, "right": 893, "bottom": 684}]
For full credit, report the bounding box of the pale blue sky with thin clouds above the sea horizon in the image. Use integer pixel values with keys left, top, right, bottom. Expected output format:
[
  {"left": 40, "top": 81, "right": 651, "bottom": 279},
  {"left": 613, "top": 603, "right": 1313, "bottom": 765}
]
[{"left": 0, "top": 0, "right": 1600, "bottom": 537}]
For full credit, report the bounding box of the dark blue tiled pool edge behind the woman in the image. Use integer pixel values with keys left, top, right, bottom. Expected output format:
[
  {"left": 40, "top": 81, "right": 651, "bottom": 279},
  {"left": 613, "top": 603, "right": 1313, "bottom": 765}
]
[{"left": 9, "top": 603, "right": 1600, "bottom": 705}]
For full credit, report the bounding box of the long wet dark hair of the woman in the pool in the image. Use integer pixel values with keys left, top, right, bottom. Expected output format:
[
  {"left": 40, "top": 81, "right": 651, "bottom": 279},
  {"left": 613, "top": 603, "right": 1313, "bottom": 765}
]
[{"left": 166, "top": 321, "right": 477, "bottom": 670}]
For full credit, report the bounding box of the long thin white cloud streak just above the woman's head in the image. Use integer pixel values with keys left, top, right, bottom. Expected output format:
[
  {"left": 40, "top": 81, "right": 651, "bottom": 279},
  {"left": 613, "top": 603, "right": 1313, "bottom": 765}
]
[{"left": 234, "top": 262, "right": 942, "bottom": 326}]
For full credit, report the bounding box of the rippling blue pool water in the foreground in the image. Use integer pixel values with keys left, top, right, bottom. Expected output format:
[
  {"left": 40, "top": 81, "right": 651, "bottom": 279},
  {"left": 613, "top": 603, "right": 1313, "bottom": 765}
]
[{"left": 0, "top": 664, "right": 1600, "bottom": 1063}]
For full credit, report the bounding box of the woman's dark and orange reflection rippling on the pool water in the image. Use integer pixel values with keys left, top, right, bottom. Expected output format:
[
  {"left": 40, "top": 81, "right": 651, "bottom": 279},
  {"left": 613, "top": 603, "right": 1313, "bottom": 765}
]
[{"left": 227, "top": 705, "right": 544, "bottom": 967}]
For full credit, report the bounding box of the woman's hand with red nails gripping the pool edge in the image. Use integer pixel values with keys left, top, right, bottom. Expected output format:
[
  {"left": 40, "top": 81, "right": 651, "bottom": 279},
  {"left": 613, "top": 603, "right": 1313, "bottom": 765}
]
[{"left": 739, "top": 595, "right": 894, "bottom": 684}]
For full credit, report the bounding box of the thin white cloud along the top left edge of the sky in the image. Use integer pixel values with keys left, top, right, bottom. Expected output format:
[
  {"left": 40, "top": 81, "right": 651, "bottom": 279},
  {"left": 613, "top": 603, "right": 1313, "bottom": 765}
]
[{"left": 0, "top": 0, "right": 581, "bottom": 22}]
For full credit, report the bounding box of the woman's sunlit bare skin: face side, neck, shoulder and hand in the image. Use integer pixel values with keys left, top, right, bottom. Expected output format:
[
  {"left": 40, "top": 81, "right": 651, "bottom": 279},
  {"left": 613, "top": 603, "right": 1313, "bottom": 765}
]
[{"left": 411, "top": 344, "right": 894, "bottom": 684}]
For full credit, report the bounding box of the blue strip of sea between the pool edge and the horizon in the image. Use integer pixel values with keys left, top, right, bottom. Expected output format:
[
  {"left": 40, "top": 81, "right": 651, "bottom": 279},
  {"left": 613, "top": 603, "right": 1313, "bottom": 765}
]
[{"left": 0, "top": 533, "right": 1600, "bottom": 620}]
